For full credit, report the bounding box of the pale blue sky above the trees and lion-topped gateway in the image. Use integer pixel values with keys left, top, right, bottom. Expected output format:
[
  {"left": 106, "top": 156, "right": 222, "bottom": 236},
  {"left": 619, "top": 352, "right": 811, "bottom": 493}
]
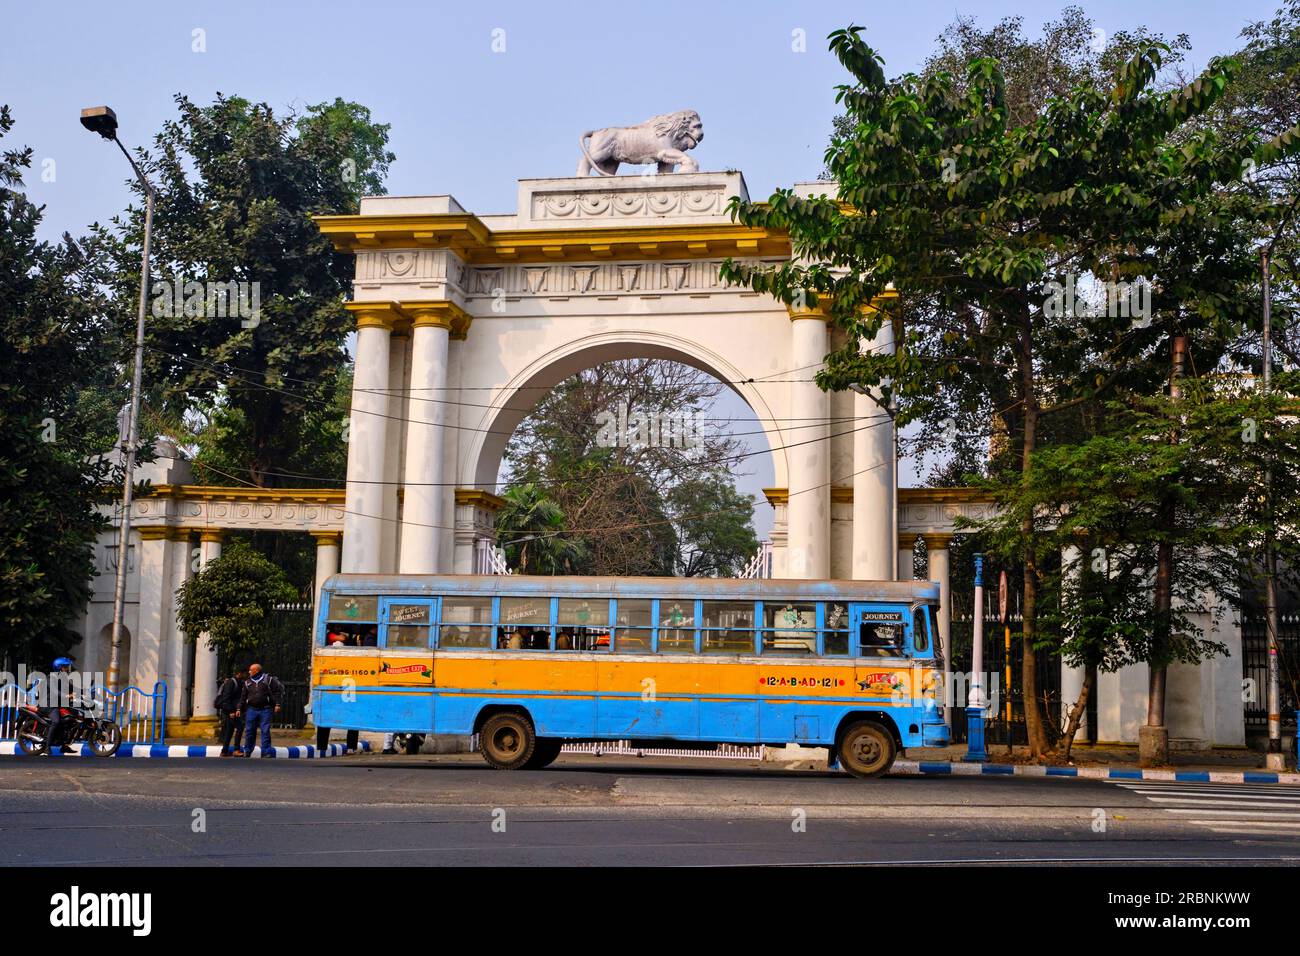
[{"left": 0, "top": 0, "right": 1281, "bottom": 533}]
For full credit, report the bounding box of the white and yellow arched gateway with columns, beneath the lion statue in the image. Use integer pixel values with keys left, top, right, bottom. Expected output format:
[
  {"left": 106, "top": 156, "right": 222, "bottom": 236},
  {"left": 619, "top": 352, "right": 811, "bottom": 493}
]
[{"left": 317, "top": 172, "right": 897, "bottom": 580}]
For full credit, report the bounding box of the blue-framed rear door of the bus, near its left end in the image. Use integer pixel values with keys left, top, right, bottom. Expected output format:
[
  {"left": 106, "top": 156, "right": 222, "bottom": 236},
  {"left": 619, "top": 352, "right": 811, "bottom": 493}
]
[{"left": 374, "top": 597, "right": 438, "bottom": 732}]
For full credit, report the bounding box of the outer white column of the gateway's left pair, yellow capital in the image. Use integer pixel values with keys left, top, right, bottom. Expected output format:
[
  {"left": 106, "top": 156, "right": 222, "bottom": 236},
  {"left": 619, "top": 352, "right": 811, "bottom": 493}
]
[{"left": 343, "top": 310, "right": 394, "bottom": 574}]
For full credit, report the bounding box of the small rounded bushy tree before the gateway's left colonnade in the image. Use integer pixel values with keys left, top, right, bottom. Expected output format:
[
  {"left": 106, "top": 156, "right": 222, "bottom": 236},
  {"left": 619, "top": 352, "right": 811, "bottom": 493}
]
[{"left": 177, "top": 538, "right": 298, "bottom": 658}]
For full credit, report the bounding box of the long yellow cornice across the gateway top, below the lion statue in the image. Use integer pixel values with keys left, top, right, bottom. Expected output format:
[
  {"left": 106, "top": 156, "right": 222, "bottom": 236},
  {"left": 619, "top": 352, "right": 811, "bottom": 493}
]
[{"left": 313, "top": 215, "right": 790, "bottom": 264}]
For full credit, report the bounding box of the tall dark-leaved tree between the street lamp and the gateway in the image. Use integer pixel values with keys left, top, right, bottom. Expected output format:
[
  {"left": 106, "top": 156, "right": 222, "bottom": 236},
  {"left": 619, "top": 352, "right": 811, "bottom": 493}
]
[{"left": 96, "top": 95, "right": 393, "bottom": 486}]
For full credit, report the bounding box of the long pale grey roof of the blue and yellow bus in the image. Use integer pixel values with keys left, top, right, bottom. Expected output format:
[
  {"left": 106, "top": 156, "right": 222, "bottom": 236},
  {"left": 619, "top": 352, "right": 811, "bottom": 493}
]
[{"left": 325, "top": 574, "right": 939, "bottom": 604}]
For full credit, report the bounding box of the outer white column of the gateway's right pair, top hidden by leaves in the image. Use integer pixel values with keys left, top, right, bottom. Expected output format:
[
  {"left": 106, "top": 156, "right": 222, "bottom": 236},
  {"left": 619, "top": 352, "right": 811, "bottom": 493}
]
[{"left": 853, "top": 321, "right": 894, "bottom": 581}]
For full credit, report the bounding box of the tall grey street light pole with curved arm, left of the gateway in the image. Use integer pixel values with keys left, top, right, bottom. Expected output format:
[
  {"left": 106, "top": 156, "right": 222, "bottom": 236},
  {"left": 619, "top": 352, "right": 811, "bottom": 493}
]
[{"left": 81, "top": 107, "right": 153, "bottom": 692}]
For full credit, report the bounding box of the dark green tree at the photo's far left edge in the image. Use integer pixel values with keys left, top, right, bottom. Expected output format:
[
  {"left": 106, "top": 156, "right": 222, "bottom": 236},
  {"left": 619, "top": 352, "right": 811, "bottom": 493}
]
[{"left": 0, "top": 107, "right": 124, "bottom": 666}]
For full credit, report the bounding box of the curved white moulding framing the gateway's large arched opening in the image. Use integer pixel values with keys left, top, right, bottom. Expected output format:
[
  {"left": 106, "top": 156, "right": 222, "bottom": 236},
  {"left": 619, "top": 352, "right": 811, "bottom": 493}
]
[{"left": 459, "top": 329, "right": 797, "bottom": 489}]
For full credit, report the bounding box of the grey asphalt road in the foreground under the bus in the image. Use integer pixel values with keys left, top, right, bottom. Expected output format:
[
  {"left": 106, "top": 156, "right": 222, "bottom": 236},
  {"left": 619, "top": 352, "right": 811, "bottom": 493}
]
[{"left": 0, "top": 756, "right": 1300, "bottom": 866}]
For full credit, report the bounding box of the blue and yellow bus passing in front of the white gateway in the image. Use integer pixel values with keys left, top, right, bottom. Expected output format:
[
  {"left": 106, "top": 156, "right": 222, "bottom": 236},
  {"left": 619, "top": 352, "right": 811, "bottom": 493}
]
[{"left": 312, "top": 575, "right": 948, "bottom": 777}]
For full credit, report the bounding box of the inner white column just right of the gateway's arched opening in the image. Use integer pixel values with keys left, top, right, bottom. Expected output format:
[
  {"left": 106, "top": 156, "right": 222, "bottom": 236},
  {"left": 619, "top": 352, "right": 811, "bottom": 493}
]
[{"left": 785, "top": 310, "right": 831, "bottom": 579}]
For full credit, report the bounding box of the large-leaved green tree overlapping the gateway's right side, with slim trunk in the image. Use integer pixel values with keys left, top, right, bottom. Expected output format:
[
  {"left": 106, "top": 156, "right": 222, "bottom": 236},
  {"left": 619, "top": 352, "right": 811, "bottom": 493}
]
[{"left": 724, "top": 27, "right": 1300, "bottom": 756}]
